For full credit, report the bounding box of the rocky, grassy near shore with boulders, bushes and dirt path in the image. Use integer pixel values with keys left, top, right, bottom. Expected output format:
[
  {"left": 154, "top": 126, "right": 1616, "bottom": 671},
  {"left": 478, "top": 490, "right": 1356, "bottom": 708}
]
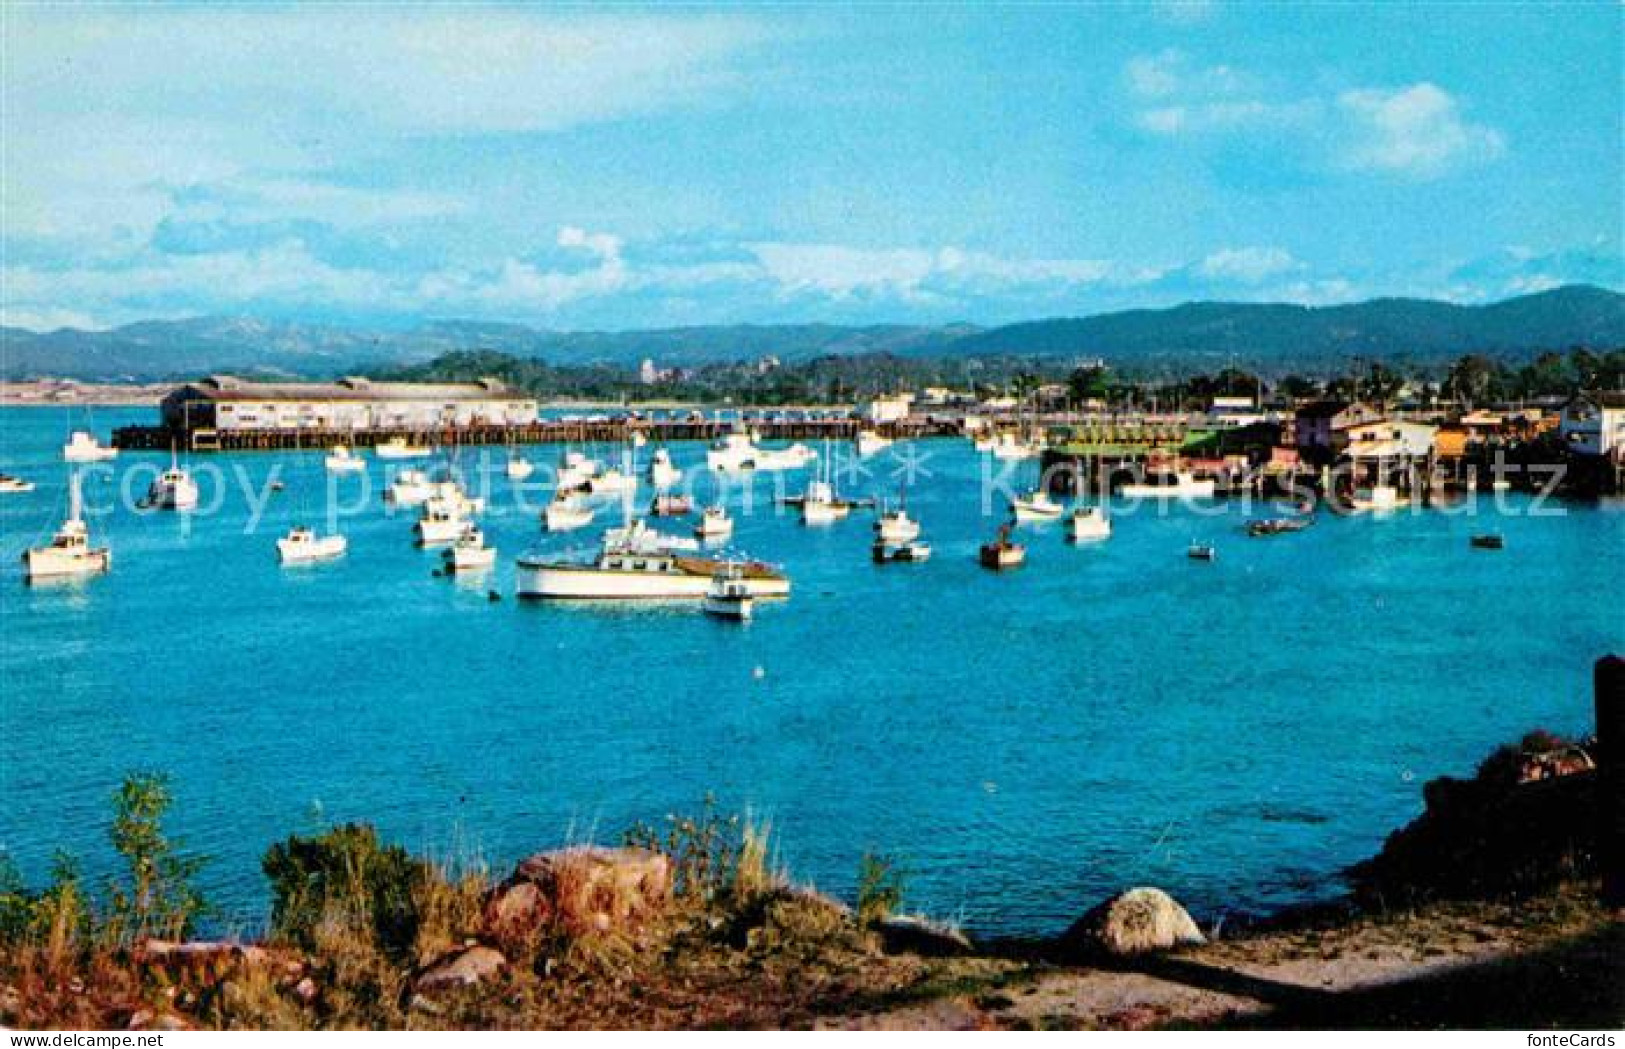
[{"left": 0, "top": 736, "right": 1625, "bottom": 1030}]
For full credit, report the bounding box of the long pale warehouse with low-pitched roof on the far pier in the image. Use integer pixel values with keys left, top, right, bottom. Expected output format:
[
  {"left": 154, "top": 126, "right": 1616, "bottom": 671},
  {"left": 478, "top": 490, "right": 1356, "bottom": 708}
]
[{"left": 159, "top": 375, "right": 538, "bottom": 434}]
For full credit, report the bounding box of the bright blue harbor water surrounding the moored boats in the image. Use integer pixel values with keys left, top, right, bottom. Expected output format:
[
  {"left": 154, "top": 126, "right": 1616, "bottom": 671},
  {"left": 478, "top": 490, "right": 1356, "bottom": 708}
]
[{"left": 0, "top": 409, "right": 1625, "bottom": 932}]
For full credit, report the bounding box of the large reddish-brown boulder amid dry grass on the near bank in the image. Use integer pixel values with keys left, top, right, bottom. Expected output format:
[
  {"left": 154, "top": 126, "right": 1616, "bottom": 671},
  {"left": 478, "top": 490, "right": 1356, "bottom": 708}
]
[{"left": 484, "top": 848, "right": 671, "bottom": 947}]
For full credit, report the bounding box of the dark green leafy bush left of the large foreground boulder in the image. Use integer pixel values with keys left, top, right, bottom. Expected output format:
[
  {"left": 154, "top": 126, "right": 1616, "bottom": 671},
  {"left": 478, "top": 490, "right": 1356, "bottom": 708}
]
[{"left": 263, "top": 823, "right": 432, "bottom": 961}]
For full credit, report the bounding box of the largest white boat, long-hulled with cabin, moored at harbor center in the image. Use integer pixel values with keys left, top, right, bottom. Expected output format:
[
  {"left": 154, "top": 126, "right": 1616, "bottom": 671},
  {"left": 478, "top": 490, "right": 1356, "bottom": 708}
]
[{"left": 515, "top": 537, "right": 790, "bottom": 601}]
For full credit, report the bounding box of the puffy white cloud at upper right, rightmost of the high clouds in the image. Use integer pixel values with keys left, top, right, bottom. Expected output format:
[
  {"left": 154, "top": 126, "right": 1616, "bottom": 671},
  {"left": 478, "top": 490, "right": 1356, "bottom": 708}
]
[{"left": 1337, "top": 83, "right": 1506, "bottom": 179}]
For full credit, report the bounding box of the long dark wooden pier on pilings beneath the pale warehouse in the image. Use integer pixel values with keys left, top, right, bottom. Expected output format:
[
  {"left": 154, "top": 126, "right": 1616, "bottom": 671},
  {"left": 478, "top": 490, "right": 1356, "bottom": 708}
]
[{"left": 112, "top": 419, "right": 960, "bottom": 451}]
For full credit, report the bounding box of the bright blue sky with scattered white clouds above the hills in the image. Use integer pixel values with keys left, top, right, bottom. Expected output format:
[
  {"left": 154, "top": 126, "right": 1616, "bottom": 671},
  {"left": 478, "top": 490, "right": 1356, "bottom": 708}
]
[{"left": 0, "top": 2, "right": 1625, "bottom": 328}]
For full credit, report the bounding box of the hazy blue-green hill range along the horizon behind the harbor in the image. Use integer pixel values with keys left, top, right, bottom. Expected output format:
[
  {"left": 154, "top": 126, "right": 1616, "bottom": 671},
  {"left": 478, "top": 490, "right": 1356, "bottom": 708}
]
[{"left": 0, "top": 286, "right": 1625, "bottom": 380}]
